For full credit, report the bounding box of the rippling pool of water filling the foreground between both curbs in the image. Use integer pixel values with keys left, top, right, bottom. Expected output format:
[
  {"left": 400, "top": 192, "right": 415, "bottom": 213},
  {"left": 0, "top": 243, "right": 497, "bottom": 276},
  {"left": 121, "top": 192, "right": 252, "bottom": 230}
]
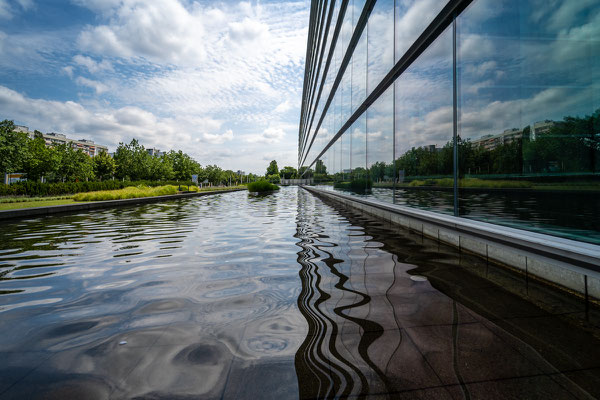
[{"left": 0, "top": 187, "right": 600, "bottom": 399}]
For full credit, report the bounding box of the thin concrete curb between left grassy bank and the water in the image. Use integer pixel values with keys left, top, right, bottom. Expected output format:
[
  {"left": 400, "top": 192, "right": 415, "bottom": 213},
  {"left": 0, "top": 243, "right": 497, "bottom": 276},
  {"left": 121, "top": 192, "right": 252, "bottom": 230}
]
[{"left": 0, "top": 189, "right": 246, "bottom": 220}]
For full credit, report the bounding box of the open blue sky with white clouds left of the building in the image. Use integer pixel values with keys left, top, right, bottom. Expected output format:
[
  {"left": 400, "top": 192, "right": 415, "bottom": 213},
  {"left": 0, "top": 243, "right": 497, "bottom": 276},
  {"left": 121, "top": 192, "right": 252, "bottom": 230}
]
[{"left": 0, "top": 0, "right": 310, "bottom": 174}]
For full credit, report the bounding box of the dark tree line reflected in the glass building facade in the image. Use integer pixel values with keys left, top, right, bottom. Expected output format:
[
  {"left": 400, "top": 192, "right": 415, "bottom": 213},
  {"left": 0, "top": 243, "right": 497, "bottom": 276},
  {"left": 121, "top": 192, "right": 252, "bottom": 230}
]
[{"left": 314, "top": 109, "right": 600, "bottom": 182}]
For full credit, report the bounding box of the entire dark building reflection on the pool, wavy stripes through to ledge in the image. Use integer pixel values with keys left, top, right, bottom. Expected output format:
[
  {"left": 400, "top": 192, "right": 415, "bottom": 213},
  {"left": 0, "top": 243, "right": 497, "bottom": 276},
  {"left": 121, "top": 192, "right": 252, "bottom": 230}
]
[{"left": 295, "top": 193, "right": 600, "bottom": 399}]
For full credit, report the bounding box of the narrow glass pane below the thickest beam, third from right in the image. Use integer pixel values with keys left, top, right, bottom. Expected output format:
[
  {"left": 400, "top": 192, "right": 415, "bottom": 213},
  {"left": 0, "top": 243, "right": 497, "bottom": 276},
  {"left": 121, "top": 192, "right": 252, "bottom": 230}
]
[{"left": 367, "top": 87, "right": 394, "bottom": 203}]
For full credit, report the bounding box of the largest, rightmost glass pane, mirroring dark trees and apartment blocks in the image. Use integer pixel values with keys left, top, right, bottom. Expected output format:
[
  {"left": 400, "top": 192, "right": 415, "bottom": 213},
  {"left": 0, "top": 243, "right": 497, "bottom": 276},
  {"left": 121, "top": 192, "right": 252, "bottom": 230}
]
[{"left": 457, "top": 0, "right": 600, "bottom": 243}]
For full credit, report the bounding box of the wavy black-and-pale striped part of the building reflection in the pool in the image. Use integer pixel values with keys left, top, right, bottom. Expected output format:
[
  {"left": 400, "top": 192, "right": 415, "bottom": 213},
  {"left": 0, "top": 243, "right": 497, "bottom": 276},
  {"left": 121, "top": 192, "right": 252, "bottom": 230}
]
[{"left": 296, "top": 193, "right": 402, "bottom": 398}]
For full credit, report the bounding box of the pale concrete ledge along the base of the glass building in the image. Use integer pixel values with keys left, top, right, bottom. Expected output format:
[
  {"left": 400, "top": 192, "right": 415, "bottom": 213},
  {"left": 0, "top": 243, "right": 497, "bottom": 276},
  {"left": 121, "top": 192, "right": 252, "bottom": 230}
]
[{"left": 302, "top": 186, "right": 600, "bottom": 299}]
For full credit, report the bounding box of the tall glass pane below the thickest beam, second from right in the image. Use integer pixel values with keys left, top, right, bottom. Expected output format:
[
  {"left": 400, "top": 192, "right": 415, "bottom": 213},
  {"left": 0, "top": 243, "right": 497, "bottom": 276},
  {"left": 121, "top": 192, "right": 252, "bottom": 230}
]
[{"left": 394, "top": 29, "right": 454, "bottom": 214}]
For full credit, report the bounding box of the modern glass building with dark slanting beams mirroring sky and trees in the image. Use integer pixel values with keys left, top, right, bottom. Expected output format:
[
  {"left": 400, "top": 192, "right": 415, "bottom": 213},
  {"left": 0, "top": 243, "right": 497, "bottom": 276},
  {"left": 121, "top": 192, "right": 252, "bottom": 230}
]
[{"left": 298, "top": 0, "right": 600, "bottom": 244}]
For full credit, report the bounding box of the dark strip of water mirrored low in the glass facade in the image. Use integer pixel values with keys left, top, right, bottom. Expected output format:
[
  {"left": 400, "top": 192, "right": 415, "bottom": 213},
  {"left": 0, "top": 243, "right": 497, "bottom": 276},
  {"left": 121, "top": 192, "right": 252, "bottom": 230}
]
[{"left": 320, "top": 185, "right": 600, "bottom": 244}]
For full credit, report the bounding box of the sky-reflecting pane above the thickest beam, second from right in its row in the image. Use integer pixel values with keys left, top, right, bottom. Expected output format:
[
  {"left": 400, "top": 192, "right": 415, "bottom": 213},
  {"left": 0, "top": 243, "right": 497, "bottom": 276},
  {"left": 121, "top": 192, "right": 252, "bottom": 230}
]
[{"left": 367, "top": 0, "right": 394, "bottom": 95}]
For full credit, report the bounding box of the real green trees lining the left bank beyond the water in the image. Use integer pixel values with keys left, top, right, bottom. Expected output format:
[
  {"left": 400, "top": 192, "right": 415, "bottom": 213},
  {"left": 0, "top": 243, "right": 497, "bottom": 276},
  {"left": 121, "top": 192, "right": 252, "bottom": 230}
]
[{"left": 0, "top": 120, "right": 256, "bottom": 185}]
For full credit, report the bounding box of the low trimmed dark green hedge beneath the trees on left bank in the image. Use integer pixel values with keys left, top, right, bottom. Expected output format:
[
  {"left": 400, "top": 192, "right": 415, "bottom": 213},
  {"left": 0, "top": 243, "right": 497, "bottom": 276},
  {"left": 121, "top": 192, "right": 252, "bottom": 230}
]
[{"left": 0, "top": 181, "right": 197, "bottom": 196}]
